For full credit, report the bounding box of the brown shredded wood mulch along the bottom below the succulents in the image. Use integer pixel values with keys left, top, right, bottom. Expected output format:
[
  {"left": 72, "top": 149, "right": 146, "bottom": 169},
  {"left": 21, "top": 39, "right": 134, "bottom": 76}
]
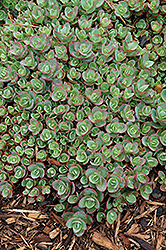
[{"left": 0, "top": 186, "right": 166, "bottom": 250}]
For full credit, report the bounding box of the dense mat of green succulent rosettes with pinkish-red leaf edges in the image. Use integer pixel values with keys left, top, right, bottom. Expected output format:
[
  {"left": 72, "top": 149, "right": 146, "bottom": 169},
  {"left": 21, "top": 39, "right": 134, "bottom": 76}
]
[{"left": 0, "top": 0, "right": 166, "bottom": 236}]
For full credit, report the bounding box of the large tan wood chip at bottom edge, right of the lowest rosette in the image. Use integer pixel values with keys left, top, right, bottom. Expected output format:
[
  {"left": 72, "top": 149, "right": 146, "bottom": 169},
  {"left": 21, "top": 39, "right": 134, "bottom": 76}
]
[{"left": 92, "top": 231, "right": 119, "bottom": 250}]
